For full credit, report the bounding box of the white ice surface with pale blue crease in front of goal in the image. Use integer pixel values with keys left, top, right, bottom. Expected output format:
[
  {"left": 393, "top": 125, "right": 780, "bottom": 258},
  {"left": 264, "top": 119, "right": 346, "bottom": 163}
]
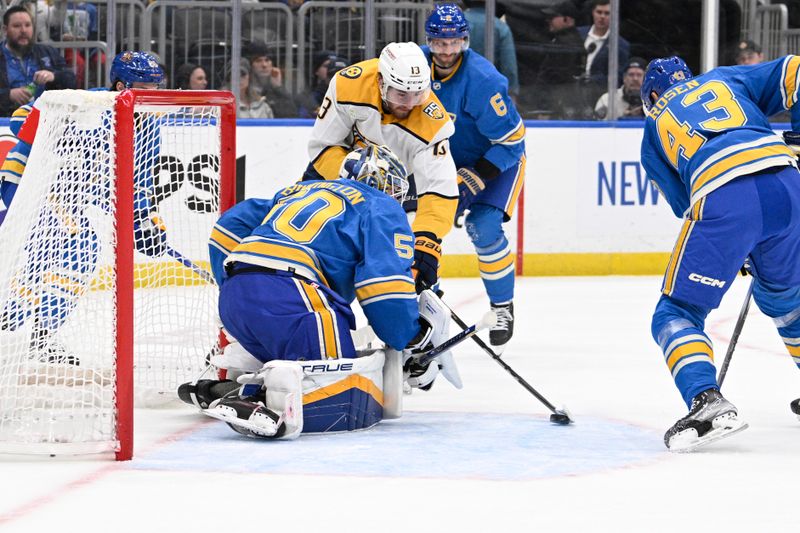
[{"left": 0, "top": 277, "right": 800, "bottom": 533}]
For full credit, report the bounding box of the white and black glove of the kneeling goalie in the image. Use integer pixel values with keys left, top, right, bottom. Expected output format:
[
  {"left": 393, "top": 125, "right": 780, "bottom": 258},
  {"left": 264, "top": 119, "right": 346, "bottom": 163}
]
[{"left": 403, "top": 290, "right": 463, "bottom": 390}]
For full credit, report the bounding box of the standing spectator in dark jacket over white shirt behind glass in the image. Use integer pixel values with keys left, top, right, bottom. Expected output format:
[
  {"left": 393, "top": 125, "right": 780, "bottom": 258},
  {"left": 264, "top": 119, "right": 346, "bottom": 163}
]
[{"left": 578, "top": 0, "right": 628, "bottom": 109}]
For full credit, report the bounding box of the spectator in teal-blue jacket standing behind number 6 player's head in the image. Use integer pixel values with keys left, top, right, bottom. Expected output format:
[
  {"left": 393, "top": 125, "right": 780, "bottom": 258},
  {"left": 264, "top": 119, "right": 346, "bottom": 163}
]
[{"left": 464, "top": 0, "right": 519, "bottom": 98}]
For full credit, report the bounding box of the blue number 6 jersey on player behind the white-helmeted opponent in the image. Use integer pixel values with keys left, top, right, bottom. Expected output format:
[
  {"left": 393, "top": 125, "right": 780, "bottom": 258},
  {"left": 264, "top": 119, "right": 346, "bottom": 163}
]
[{"left": 422, "top": 46, "right": 525, "bottom": 172}]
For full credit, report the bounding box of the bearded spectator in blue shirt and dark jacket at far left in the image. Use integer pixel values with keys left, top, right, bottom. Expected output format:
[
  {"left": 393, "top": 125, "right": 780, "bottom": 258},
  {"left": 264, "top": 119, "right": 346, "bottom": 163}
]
[{"left": 0, "top": 6, "right": 76, "bottom": 117}]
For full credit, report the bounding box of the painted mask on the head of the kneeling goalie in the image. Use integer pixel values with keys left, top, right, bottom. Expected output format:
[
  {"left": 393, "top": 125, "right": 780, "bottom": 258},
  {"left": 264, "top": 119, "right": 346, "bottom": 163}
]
[{"left": 339, "top": 144, "right": 408, "bottom": 203}]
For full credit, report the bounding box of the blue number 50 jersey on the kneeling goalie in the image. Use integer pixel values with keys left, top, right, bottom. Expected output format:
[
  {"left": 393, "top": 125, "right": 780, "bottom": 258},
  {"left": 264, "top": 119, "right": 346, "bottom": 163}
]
[{"left": 209, "top": 179, "right": 419, "bottom": 349}]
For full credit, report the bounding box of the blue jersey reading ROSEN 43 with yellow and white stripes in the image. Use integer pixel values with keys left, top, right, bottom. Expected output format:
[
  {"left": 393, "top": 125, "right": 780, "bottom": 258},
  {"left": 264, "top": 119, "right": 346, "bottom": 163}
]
[{"left": 641, "top": 56, "right": 800, "bottom": 217}]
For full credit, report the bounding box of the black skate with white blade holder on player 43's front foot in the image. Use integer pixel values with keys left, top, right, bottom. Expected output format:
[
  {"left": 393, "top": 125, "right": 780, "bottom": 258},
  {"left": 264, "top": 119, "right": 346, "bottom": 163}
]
[{"left": 664, "top": 389, "right": 747, "bottom": 452}]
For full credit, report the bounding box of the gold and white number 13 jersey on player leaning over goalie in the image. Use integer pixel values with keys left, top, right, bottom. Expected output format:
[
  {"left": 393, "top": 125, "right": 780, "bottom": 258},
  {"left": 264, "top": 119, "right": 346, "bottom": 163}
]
[{"left": 308, "top": 59, "right": 458, "bottom": 239}]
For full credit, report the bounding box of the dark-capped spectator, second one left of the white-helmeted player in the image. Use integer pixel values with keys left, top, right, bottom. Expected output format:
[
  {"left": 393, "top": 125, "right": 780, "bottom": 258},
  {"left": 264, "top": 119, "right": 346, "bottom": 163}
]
[{"left": 242, "top": 41, "right": 297, "bottom": 118}]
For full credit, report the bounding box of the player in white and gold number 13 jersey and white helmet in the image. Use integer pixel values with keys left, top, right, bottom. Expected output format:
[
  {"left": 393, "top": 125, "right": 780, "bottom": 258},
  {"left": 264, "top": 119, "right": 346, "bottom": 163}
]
[{"left": 303, "top": 42, "right": 459, "bottom": 293}]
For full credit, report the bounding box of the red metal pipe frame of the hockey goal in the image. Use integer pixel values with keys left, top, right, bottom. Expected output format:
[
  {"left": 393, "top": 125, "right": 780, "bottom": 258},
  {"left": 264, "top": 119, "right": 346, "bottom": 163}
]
[{"left": 114, "top": 89, "right": 236, "bottom": 461}]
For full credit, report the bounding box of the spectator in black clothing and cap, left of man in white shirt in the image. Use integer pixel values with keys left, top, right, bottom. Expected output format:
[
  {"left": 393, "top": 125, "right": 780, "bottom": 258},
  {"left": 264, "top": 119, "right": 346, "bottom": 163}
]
[{"left": 527, "top": 0, "right": 591, "bottom": 119}]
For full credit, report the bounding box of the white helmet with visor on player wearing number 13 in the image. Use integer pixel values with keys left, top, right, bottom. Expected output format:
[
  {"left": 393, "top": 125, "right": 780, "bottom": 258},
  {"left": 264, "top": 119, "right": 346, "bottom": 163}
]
[{"left": 378, "top": 42, "right": 431, "bottom": 107}]
